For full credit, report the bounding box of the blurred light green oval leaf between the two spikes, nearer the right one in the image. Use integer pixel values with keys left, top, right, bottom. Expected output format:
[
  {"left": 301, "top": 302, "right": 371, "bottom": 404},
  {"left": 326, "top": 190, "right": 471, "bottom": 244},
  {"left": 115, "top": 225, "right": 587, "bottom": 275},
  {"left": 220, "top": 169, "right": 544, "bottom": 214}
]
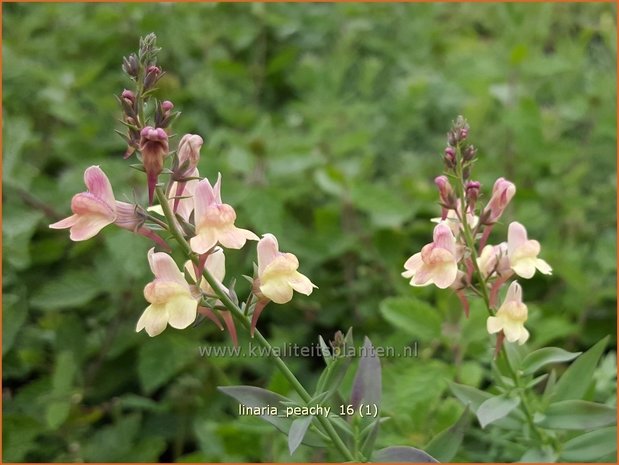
[{"left": 380, "top": 297, "right": 441, "bottom": 341}]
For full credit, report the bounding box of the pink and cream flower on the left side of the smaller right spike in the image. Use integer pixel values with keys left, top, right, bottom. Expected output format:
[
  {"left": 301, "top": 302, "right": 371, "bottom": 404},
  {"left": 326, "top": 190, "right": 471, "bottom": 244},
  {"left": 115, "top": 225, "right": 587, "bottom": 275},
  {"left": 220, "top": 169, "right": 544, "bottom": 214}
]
[{"left": 402, "top": 223, "right": 459, "bottom": 289}]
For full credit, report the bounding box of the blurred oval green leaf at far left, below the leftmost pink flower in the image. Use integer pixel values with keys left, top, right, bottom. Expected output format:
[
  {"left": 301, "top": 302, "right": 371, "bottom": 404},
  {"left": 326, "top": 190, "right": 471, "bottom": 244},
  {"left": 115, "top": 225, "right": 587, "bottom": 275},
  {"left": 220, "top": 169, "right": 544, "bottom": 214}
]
[{"left": 30, "top": 270, "right": 101, "bottom": 310}]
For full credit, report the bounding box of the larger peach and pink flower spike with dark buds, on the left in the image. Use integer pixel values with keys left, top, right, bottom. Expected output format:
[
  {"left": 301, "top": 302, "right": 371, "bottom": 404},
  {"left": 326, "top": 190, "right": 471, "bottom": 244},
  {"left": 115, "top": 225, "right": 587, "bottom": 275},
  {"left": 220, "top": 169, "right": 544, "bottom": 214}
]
[{"left": 50, "top": 34, "right": 316, "bottom": 338}]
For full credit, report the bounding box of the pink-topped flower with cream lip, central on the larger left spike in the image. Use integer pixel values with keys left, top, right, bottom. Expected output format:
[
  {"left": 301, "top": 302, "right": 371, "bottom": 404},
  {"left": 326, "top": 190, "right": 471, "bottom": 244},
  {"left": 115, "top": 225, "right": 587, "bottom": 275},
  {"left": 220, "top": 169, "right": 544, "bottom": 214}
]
[{"left": 190, "top": 174, "right": 259, "bottom": 254}]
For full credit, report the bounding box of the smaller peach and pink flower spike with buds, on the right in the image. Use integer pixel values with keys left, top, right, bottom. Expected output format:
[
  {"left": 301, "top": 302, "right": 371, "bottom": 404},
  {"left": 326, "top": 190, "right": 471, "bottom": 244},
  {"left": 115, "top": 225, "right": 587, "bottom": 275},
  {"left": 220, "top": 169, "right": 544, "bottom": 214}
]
[{"left": 402, "top": 117, "right": 552, "bottom": 348}]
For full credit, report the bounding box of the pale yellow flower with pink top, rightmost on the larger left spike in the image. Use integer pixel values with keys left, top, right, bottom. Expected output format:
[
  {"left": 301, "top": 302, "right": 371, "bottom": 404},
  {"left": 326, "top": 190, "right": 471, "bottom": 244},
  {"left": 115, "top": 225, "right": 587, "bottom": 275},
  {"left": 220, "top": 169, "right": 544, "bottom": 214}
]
[{"left": 258, "top": 234, "right": 317, "bottom": 304}]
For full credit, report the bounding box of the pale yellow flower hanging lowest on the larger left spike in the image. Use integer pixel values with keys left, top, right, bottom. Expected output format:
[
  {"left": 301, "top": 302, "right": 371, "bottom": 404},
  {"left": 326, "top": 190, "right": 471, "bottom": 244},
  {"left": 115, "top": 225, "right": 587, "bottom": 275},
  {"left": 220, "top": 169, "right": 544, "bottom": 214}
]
[{"left": 135, "top": 249, "right": 199, "bottom": 336}]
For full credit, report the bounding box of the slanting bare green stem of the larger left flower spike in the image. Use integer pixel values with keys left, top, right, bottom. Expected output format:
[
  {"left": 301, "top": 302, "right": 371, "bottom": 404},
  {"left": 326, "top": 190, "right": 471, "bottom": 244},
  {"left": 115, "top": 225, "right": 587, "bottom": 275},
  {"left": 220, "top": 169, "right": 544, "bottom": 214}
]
[{"left": 155, "top": 186, "right": 355, "bottom": 462}]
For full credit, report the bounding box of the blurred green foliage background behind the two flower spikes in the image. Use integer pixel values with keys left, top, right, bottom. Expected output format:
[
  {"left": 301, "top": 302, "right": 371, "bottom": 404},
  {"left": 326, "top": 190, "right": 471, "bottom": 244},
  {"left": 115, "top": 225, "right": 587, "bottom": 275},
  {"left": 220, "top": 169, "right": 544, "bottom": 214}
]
[{"left": 2, "top": 3, "right": 616, "bottom": 462}]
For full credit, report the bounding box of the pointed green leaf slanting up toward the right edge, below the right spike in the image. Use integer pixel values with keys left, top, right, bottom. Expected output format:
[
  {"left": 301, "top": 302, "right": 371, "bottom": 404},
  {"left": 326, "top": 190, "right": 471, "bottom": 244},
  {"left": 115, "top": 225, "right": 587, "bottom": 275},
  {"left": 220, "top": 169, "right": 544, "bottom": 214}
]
[{"left": 551, "top": 336, "right": 608, "bottom": 402}]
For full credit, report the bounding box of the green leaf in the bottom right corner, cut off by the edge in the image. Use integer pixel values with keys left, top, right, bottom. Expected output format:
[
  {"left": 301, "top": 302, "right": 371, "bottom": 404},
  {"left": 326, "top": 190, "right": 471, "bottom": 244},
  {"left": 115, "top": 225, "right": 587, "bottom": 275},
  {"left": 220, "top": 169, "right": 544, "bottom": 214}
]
[{"left": 560, "top": 426, "right": 617, "bottom": 462}]
